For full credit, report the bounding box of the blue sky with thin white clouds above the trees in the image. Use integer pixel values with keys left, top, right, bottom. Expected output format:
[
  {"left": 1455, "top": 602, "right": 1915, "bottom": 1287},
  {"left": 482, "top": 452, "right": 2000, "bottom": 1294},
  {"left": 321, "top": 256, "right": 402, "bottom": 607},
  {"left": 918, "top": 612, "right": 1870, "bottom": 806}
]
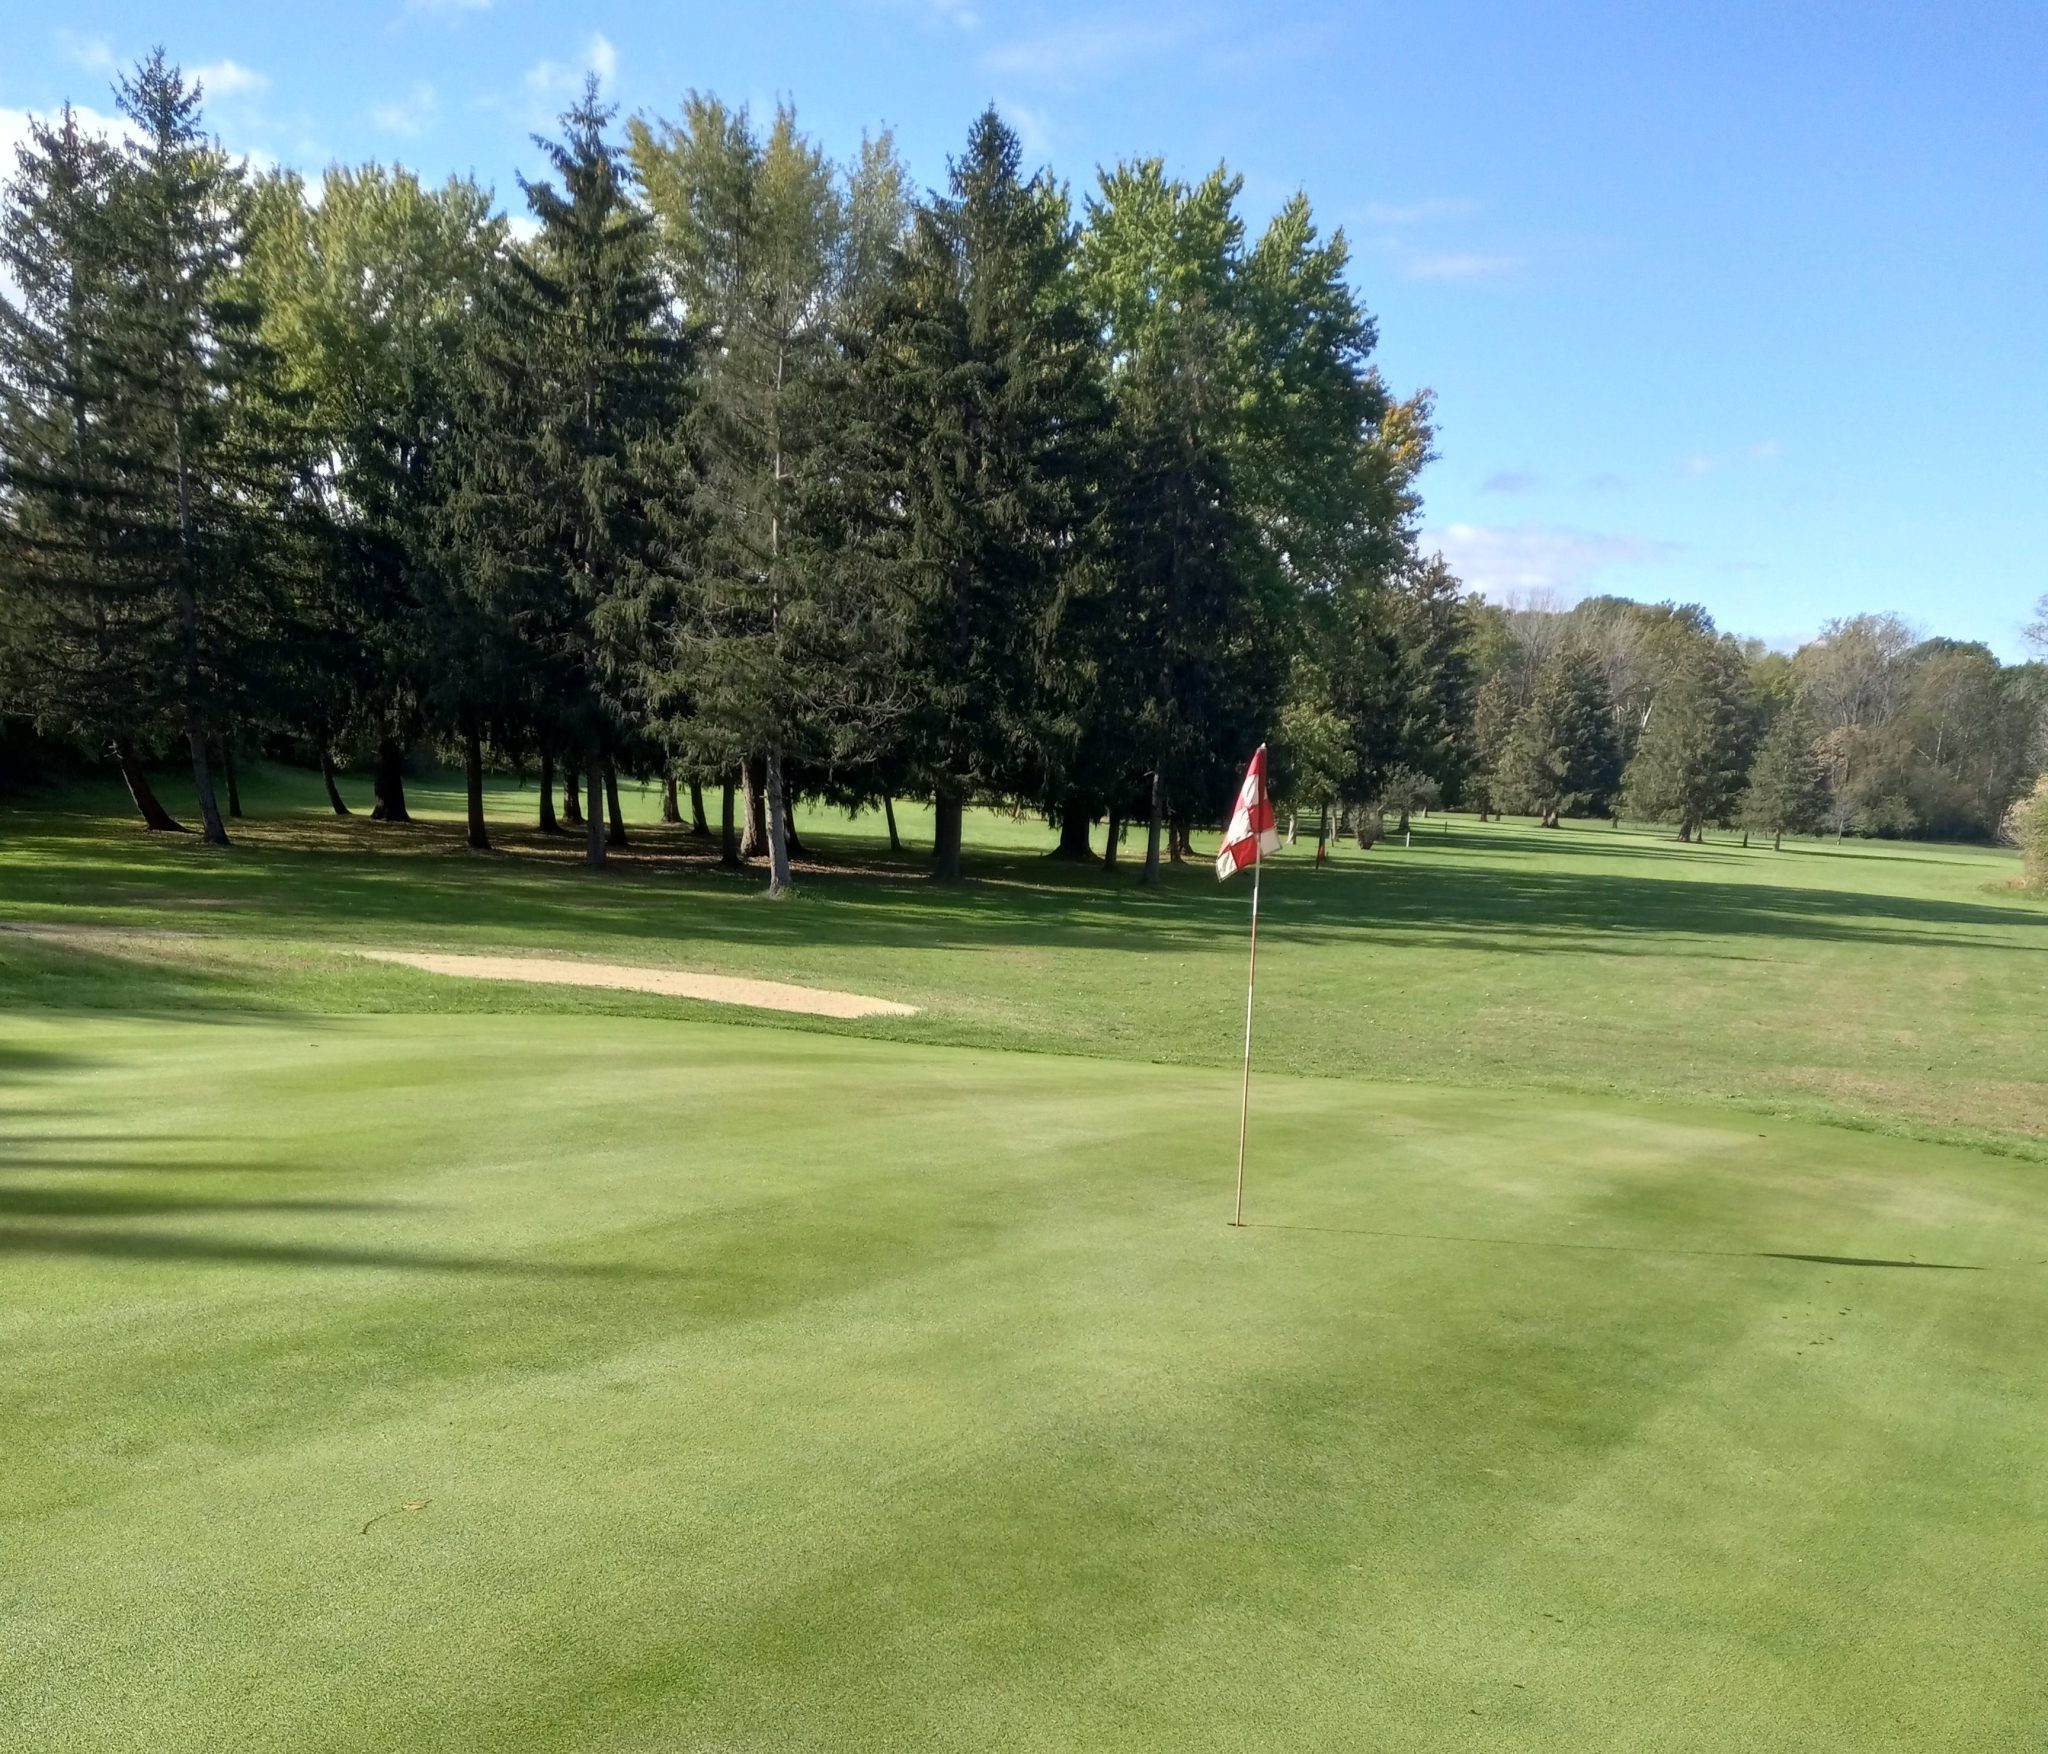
[{"left": 0, "top": 0, "right": 2048, "bottom": 658}]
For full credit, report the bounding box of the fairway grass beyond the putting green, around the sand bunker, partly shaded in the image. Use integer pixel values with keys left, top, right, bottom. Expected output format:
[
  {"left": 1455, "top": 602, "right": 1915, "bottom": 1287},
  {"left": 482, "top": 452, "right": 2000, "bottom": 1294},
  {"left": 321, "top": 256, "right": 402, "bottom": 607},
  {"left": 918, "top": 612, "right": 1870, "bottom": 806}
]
[{"left": 0, "top": 772, "right": 2048, "bottom": 1158}]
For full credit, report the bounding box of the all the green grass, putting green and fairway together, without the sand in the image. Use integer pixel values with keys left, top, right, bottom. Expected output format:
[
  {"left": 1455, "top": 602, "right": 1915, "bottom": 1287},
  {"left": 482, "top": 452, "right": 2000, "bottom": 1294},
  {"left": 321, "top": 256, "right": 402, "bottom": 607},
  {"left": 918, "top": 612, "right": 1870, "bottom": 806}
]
[{"left": 0, "top": 775, "right": 2048, "bottom": 1754}]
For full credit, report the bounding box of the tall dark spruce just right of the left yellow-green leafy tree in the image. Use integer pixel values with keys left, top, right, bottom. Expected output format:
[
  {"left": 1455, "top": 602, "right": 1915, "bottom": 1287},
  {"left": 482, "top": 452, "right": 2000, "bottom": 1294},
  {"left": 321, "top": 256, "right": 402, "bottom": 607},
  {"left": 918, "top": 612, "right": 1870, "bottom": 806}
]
[{"left": 434, "top": 80, "right": 688, "bottom": 865}]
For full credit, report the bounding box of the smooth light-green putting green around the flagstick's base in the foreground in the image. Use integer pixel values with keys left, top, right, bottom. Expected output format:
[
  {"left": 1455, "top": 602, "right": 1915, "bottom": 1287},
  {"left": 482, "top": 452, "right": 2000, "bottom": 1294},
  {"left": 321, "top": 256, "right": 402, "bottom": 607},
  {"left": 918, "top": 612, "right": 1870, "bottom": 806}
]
[{"left": 0, "top": 1012, "right": 2048, "bottom": 1754}]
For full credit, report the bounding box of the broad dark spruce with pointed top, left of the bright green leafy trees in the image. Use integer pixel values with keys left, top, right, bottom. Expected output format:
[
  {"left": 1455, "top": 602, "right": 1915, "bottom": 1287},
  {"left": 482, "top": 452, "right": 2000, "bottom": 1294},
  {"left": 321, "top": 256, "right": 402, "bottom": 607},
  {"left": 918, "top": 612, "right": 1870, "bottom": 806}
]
[{"left": 842, "top": 111, "right": 1096, "bottom": 879}]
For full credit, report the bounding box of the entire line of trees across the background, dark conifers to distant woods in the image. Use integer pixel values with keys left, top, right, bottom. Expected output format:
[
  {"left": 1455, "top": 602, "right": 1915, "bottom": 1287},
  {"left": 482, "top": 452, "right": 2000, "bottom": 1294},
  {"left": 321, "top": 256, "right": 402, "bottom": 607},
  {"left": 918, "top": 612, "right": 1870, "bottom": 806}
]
[{"left": 0, "top": 53, "right": 2048, "bottom": 893}]
